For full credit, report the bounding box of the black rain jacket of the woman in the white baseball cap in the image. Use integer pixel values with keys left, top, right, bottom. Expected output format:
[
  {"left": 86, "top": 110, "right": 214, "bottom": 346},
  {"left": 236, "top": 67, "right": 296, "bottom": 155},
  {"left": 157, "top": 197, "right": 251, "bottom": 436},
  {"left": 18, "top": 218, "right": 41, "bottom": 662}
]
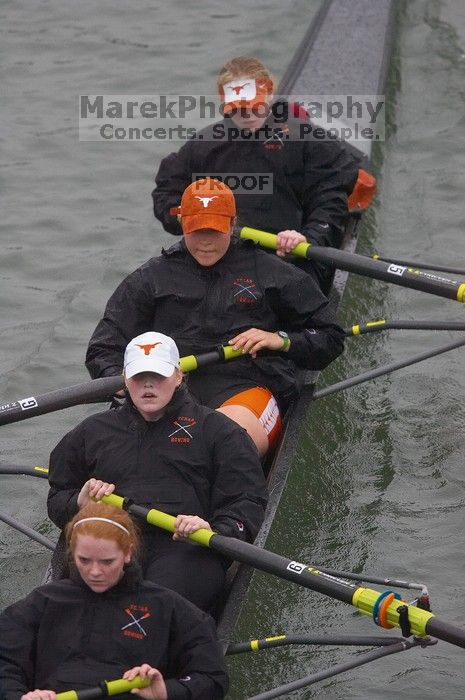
[{"left": 47, "top": 387, "right": 266, "bottom": 546}]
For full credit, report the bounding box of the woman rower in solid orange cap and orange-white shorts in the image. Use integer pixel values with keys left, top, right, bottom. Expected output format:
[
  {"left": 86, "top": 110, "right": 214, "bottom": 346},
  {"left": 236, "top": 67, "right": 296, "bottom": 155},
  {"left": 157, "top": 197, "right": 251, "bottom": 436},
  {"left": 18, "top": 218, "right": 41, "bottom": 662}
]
[{"left": 86, "top": 178, "right": 344, "bottom": 455}]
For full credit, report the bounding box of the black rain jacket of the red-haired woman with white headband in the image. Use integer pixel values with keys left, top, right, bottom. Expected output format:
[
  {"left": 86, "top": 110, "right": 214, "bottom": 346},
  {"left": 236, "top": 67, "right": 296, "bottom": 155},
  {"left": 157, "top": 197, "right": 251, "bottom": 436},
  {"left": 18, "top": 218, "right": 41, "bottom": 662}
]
[{"left": 0, "top": 566, "right": 228, "bottom": 700}]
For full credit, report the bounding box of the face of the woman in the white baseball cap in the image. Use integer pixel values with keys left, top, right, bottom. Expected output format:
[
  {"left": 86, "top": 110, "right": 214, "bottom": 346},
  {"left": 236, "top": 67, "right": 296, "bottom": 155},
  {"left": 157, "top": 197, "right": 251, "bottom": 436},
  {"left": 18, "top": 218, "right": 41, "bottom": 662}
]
[{"left": 126, "top": 369, "right": 182, "bottom": 421}]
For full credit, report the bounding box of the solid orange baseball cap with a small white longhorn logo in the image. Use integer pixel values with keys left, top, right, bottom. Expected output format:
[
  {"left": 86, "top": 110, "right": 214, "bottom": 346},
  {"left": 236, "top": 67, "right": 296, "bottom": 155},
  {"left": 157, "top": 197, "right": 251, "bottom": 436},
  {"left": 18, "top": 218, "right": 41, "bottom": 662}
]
[{"left": 170, "top": 177, "right": 236, "bottom": 234}]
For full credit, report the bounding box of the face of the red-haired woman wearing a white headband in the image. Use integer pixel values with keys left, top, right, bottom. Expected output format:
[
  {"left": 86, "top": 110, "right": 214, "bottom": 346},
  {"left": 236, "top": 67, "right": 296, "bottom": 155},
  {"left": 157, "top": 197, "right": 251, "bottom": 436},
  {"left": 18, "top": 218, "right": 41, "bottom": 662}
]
[{"left": 73, "top": 535, "right": 131, "bottom": 593}]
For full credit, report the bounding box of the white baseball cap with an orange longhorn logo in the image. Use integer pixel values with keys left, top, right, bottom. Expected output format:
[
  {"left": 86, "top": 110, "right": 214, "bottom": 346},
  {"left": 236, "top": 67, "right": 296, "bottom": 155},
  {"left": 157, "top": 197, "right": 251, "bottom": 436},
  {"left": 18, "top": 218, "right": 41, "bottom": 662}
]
[{"left": 124, "top": 331, "right": 179, "bottom": 379}]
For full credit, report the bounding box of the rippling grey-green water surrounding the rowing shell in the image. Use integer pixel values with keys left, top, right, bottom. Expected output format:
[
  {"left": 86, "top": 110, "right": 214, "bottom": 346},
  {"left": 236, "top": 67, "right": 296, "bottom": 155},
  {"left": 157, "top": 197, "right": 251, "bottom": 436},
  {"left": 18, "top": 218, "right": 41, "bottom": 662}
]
[{"left": 0, "top": 0, "right": 465, "bottom": 700}]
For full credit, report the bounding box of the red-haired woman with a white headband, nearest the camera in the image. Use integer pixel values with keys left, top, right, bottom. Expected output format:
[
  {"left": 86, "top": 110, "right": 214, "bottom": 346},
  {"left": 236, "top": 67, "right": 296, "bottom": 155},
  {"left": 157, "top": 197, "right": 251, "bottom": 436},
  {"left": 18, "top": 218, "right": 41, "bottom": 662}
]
[{"left": 0, "top": 503, "right": 228, "bottom": 700}]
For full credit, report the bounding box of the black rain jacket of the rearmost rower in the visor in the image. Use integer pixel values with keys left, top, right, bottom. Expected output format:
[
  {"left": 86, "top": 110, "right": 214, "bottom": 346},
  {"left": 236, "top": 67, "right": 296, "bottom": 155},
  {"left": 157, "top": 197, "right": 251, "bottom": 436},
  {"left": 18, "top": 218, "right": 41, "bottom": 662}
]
[{"left": 152, "top": 102, "right": 360, "bottom": 248}]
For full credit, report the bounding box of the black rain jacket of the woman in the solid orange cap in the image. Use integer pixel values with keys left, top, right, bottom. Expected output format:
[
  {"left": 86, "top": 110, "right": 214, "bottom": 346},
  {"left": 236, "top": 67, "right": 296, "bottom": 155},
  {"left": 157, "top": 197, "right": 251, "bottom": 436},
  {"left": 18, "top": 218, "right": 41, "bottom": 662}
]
[{"left": 86, "top": 238, "right": 344, "bottom": 406}]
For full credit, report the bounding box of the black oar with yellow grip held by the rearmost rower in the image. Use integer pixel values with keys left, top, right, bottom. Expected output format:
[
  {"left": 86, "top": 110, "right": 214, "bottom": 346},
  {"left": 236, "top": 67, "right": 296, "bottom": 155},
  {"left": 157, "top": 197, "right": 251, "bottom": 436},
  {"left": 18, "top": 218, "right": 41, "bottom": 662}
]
[{"left": 240, "top": 226, "right": 465, "bottom": 303}]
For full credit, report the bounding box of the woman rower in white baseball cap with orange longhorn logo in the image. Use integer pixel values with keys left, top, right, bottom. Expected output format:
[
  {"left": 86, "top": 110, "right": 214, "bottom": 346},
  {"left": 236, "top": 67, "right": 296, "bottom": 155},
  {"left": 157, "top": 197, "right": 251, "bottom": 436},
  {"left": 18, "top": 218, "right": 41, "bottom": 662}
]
[{"left": 48, "top": 332, "right": 266, "bottom": 612}]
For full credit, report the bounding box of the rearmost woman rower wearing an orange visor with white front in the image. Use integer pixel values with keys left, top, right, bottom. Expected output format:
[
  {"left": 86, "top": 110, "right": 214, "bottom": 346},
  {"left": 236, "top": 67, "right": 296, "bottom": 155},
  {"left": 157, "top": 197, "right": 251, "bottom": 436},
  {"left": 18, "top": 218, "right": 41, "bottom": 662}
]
[{"left": 152, "top": 51, "right": 359, "bottom": 288}]
